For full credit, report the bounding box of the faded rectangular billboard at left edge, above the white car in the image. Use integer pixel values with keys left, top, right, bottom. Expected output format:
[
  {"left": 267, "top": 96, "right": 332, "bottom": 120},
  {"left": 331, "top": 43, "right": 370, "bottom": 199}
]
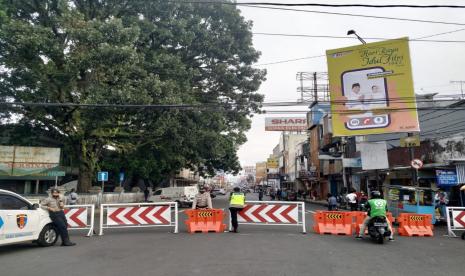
[{"left": 0, "top": 146, "right": 61, "bottom": 176}]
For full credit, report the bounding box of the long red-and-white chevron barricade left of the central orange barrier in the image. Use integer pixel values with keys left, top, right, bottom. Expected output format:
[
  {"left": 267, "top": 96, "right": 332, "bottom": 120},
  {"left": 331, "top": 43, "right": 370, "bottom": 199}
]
[{"left": 99, "top": 202, "right": 178, "bottom": 235}]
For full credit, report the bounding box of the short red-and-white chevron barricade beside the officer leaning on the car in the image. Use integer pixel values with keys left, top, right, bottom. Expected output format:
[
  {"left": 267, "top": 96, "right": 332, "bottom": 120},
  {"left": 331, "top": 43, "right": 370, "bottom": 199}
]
[{"left": 64, "top": 204, "right": 95, "bottom": 237}]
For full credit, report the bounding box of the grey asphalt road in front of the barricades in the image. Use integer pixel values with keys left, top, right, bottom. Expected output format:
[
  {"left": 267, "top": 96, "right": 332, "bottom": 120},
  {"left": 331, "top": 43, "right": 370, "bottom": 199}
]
[{"left": 0, "top": 196, "right": 465, "bottom": 276}]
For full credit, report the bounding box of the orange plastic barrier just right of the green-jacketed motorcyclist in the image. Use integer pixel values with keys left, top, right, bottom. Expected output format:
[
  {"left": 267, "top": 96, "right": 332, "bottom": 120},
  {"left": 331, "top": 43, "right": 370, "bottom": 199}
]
[{"left": 397, "top": 213, "right": 433, "bottom": 237}]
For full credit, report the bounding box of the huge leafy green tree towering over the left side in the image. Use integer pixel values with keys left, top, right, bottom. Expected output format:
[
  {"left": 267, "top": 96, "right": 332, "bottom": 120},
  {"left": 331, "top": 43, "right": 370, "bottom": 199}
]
[{"left": 0, "top": 0, "right": 265, "bottom": 190}]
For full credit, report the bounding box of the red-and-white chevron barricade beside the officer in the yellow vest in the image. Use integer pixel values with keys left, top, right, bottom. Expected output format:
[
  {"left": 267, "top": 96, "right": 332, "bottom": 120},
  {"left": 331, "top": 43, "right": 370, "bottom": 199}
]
[{"left": 229, "top": 201, "right": 307, "bottom": 233}]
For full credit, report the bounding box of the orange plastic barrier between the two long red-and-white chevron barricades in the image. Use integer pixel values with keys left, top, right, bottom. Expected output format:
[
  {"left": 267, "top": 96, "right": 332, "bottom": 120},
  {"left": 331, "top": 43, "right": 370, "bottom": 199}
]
[{"left": 185, "top": 209, "right": 226, "bottom": 233}]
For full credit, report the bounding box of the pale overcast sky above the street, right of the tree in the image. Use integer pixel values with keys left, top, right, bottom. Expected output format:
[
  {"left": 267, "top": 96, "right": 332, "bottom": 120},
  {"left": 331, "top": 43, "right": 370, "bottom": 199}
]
[{"left": 237, "top": 0, "right": 465, "bottom": 167}]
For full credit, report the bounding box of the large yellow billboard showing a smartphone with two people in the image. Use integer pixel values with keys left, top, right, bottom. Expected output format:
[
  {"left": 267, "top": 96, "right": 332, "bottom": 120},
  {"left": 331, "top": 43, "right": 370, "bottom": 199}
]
[{"left": 326, "top": 38, "right": 420, "bottom": 136}]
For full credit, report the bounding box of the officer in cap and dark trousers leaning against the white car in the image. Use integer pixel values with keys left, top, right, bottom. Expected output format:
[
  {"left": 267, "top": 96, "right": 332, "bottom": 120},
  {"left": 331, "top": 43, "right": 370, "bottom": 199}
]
[{"left": 41, "top": 188, "right": 76, "bottom": 246}]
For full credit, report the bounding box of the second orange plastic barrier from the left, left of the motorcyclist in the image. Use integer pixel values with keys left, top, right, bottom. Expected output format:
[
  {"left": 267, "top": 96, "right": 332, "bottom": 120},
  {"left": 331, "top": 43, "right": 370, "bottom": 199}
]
[{"left": 313, "top": 211, "right": 353, "bottom": 235}]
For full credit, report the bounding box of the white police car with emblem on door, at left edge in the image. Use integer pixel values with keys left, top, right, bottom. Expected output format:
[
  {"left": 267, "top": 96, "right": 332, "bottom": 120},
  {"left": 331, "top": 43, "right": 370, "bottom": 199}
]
[{"left": 0, "top": 189, "right": 58, "bottom": 246}]
